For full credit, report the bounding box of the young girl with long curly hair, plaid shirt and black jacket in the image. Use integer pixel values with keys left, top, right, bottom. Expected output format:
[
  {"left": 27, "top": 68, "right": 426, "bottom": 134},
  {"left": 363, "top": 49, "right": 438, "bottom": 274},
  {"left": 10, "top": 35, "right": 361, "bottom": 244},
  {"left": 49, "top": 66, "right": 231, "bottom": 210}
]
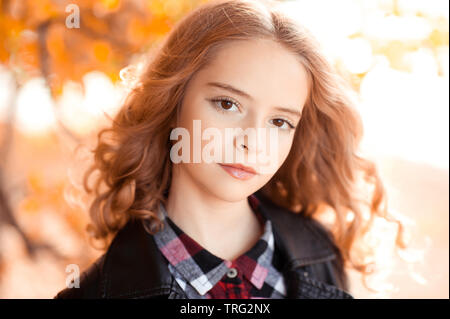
[{"left": 56, "top": 0, "right": 406, "bottom": 298}]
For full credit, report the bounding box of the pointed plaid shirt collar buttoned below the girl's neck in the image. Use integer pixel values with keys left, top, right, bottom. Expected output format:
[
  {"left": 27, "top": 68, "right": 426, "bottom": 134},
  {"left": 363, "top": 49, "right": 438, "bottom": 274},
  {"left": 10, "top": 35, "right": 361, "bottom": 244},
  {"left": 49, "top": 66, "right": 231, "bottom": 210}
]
[{"left": 154, "top": 195, "right": 274, "bottom": 295}]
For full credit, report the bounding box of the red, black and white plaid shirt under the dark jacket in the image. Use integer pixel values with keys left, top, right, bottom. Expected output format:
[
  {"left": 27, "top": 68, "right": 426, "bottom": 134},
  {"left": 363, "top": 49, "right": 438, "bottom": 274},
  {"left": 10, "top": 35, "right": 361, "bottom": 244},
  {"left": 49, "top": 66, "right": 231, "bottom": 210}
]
[{"left": 154, "top": 195, "right": 286, "bottom": 299}]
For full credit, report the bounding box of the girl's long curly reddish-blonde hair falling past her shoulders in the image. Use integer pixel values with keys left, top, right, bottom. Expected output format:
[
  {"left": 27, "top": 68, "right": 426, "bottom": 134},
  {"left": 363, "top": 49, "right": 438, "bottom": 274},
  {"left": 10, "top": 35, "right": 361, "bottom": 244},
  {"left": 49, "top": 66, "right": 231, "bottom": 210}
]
[{"left": 76, "top": 0, "right": 412, "bottom": 296}]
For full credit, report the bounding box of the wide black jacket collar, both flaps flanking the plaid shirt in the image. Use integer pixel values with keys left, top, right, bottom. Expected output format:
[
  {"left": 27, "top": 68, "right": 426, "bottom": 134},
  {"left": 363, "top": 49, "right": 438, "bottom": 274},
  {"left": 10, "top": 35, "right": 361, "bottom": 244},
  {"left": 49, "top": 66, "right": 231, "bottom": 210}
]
[{"left": 101, "top": 192, "right": 336, "bottom": 298}]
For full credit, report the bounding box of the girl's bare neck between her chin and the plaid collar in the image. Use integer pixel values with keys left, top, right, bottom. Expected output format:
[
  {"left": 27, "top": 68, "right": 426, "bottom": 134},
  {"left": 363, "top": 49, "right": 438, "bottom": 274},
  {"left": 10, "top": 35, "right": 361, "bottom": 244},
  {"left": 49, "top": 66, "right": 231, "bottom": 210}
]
[{"left": 166, "top": 165, "right": 263, "bottom": 261}]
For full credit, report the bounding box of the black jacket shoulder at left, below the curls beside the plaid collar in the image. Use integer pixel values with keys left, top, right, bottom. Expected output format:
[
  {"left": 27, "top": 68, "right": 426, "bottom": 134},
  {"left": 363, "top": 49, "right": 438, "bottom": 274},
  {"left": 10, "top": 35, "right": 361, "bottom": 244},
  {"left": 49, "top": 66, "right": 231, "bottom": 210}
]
[{"left": 54, "top": 218, "right": 162, "bottom": 299}]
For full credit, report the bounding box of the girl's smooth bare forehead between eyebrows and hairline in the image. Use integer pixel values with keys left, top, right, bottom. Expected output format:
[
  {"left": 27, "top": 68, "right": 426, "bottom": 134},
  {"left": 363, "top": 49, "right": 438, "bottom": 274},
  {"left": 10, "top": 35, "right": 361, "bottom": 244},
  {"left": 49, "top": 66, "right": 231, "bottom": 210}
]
[{"left": 195, "top": 39, "right": 308, "bottom": 107}]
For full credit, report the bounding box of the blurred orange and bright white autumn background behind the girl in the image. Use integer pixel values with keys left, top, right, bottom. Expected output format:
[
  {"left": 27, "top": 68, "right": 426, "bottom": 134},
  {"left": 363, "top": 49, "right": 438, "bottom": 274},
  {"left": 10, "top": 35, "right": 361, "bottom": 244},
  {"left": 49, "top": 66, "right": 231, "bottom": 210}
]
[{"left": 0, "top": 0, "right": 449, "bottom": 298}]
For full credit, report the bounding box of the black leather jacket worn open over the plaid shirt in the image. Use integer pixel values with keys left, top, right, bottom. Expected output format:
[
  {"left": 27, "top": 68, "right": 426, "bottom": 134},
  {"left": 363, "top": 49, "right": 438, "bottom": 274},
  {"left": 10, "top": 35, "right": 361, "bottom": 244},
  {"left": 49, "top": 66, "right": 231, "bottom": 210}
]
[{"left": 54, "top": 192, "right": 353, "bottom": 299}]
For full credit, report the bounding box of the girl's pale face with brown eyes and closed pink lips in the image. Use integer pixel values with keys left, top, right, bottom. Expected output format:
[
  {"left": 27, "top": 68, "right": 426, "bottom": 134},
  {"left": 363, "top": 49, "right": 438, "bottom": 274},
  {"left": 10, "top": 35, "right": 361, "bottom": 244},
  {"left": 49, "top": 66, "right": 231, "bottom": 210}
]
[{"left": 174, "top": 40, "right": 308, "bottom": 201}]
